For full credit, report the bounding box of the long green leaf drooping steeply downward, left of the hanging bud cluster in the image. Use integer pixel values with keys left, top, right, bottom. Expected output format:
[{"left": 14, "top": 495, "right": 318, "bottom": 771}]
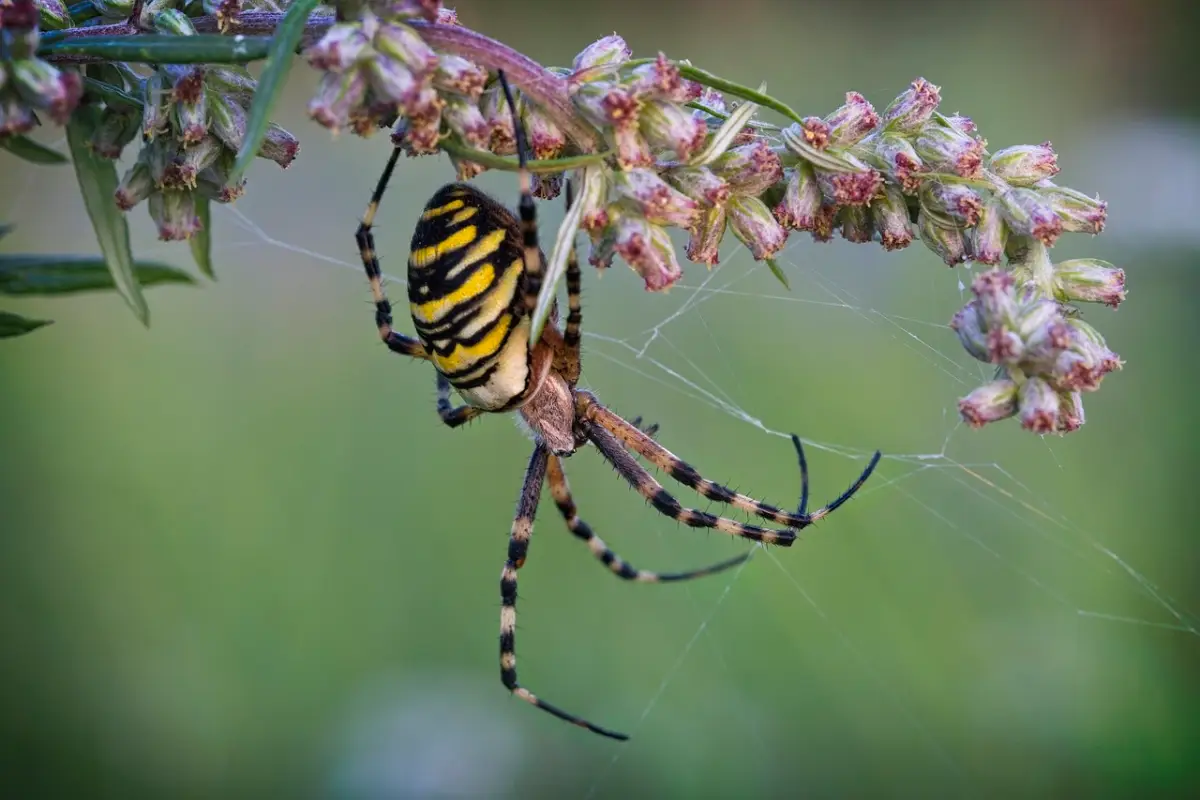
[{"left": 67, "top": 106, "right": 150, "bottom": 326}]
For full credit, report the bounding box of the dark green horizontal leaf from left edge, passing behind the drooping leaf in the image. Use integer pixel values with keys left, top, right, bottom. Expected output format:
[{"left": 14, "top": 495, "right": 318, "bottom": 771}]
[{"left": 0, "top": 253, "right": 196, "bottom": 295}]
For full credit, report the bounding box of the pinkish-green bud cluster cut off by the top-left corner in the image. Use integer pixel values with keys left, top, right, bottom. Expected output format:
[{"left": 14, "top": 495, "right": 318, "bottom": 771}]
[{"left": 0, "top": 0, "right": 83, "bottom": 139}]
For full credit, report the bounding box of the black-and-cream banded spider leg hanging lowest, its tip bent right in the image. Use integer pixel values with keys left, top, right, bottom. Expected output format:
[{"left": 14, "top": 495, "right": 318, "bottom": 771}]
[{"left": 500, "top": 444, "right": 629, "bottom": 740}]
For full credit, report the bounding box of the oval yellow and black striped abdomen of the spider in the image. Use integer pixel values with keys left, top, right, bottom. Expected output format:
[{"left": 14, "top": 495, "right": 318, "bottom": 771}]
[{"left": 408, "top": 184, "right": 530, "bottom": 411}]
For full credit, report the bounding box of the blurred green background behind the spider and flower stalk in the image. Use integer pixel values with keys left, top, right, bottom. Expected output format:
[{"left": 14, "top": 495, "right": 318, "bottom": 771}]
[{"left": 0, "top": 0, "right": 1200, "bottom": 800}]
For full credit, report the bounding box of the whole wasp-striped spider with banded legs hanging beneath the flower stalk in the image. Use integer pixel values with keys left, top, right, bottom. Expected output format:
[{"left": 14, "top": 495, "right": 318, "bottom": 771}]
[{"left": 355, "top": 72, "right": 880, "bottom": 740}]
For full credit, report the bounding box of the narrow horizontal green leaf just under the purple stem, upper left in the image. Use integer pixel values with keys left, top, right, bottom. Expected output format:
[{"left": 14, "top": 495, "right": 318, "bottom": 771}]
[{"left": 37, "top": 34, "right": 272, "bottom": 64}]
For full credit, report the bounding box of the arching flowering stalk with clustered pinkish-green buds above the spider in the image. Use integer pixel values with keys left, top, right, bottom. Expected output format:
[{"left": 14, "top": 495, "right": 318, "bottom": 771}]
[{"left": 7, "top": 0, "right": 1124, "bottom": 432}]
